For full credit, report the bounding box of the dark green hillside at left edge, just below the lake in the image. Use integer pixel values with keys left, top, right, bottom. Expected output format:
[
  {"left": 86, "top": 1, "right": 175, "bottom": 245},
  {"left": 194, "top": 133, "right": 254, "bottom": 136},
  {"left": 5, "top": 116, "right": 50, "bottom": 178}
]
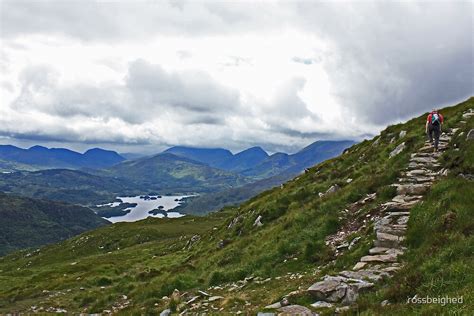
[{"left": 0, "top": 192, "right": 110, "bottom": 256}]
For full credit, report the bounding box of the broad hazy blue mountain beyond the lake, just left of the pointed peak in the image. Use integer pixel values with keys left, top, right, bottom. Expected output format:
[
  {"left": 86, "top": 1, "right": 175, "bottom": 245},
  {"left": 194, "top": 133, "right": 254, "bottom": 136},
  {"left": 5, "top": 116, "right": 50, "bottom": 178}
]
[{"left": 164, "top": 146, "right": 233, "bottom": 167}]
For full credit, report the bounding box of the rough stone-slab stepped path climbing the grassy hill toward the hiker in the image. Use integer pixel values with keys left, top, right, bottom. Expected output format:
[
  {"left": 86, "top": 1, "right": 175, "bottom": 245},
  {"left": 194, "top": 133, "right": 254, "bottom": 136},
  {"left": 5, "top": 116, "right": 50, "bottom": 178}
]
[{"left": 270, "top": 119, "right": 466, "bottom": 315}]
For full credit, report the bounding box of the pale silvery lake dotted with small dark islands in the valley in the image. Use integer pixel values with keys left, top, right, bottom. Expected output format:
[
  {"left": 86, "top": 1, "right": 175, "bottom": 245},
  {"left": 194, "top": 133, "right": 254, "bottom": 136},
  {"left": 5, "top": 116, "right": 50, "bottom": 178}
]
[{"left": 104, "top": 195, "right": 189, "bottom": 223}]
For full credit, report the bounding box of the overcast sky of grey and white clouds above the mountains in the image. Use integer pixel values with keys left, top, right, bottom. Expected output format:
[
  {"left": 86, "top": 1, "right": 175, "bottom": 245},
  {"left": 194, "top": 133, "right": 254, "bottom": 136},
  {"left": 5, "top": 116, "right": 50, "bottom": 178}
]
[{"left": 0, "top": 0, "right": 474, "bottom": 154}]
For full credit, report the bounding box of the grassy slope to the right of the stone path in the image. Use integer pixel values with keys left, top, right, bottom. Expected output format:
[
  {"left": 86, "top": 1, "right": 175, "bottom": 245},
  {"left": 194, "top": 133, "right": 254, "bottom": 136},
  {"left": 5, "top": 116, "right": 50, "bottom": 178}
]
[{"left": 361, "top": 108, "right": 474, "bottom": 315}]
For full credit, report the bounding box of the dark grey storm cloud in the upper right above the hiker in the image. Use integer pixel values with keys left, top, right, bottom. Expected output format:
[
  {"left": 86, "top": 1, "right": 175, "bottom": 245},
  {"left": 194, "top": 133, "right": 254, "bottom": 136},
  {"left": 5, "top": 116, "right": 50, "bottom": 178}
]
[{"left": 295, "top": 2, "right": 474, "bottom": 125}]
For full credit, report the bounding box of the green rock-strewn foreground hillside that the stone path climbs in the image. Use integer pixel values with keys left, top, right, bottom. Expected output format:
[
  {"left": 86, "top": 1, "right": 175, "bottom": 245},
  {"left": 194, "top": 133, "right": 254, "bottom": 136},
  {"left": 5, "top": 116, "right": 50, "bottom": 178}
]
[{"left": 0, "top": 98, "right": 474, "bottom": 315}]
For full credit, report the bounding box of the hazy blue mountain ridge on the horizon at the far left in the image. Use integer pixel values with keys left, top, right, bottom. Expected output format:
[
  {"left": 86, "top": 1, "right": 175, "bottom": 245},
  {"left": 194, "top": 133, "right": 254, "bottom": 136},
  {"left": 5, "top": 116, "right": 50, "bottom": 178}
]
[{"left": 0, "top": 145, "right": 125, "bottom": 169}]
